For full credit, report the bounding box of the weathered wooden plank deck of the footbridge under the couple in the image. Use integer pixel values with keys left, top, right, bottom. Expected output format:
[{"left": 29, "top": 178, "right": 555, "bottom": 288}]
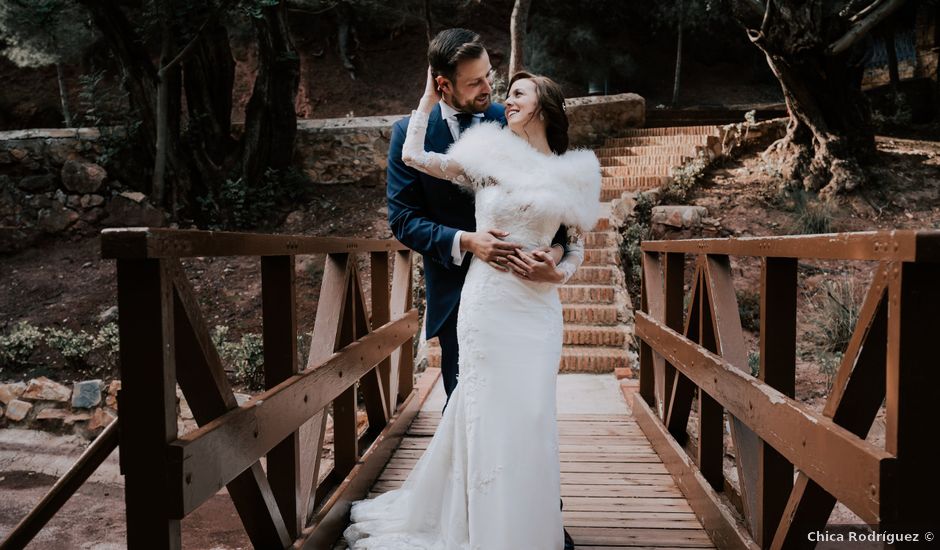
[{"left": 336, "top": 375, "right": 715, "bottom": 550}]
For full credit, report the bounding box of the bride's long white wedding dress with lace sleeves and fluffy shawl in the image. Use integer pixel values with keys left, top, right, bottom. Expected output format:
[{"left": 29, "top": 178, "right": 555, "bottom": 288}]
[{"left": 344, "top": 112, "right": 600, "bottom": 550}]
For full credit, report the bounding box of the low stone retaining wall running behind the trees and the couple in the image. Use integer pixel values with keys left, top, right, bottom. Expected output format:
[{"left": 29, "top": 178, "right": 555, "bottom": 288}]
[{"left": 0, "top": 94, "right": 646, "bottom": 254}]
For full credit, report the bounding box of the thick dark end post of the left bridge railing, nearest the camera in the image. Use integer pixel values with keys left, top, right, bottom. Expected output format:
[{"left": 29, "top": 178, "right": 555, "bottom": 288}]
[{"left": 117, "top": 259, "right": 181, "bottom": 550}]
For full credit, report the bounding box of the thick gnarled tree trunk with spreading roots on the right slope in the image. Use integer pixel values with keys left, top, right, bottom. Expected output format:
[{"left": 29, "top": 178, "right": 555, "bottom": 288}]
[{"left": 754, "top": 0, "right": 875, "bottom": 198}]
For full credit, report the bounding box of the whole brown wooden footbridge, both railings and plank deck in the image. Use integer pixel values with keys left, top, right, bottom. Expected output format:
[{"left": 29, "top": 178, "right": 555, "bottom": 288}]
[{"left": 2, "top": 229, "right": 940, "bottom": 549}]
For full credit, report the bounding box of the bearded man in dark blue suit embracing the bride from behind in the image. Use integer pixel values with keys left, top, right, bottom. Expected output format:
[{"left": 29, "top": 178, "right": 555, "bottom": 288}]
[{"left": 386, "top": 29, "right": 574, "bottom": 550}]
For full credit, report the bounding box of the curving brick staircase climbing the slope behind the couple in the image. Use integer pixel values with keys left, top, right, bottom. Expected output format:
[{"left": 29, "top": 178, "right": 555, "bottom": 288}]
[{"left": 427, "top": 126, "right": 718, "bottom": 373}]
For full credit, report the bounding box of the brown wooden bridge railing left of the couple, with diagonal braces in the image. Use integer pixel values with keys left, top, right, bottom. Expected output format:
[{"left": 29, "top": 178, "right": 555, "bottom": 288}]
[{"left": 3, "top": 228, "right": 419, "bottom": 549}]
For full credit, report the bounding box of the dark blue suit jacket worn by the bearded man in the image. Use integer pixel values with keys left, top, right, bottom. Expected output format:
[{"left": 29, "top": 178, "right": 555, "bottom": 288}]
[{"left": 386, "top": 103, "right": 565, "bottom": 338}]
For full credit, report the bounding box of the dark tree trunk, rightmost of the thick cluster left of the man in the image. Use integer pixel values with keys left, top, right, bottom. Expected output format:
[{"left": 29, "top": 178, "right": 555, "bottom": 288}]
[{"left": 242, "top": 2, "right": 300, "bottom": 185}]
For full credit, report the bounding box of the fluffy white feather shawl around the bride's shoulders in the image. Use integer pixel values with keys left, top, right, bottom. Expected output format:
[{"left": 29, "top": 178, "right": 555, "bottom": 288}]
[{"left": 447, "top": 122, "right": 601, "bottom": 231}]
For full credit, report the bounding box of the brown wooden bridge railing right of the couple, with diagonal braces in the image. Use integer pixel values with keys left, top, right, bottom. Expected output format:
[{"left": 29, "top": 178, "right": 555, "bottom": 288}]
[{"left": 634, "top": 231, "right": 940, "bottom": 549}]
